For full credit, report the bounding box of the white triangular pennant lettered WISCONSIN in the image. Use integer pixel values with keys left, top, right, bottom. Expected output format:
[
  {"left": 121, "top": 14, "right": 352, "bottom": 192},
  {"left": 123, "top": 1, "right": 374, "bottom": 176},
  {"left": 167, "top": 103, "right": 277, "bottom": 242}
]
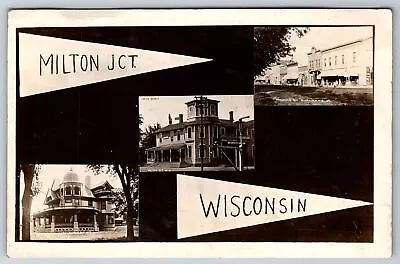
[{"left": 177, "top": 174, "right": 372, "bottom": 239}]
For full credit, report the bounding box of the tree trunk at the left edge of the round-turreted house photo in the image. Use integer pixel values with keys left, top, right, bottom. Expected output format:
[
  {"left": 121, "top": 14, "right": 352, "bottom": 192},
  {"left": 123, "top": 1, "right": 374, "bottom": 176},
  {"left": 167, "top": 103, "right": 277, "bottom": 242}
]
[{"left": 18, "top": 164, "right": 42, "bottom": 241}]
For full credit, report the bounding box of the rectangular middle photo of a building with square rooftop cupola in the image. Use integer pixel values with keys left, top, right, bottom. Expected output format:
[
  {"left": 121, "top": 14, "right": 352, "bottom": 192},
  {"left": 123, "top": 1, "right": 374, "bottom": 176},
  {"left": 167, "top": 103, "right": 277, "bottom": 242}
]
[{"left": 139, "top": 95, "right": 255, "bottom": 172}]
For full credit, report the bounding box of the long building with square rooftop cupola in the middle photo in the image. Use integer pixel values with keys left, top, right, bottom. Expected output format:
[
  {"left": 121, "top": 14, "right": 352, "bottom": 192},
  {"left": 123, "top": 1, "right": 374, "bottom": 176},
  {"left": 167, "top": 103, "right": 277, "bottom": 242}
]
[{"left": 146, "top": 99, "right": 254, "bottom": 167}]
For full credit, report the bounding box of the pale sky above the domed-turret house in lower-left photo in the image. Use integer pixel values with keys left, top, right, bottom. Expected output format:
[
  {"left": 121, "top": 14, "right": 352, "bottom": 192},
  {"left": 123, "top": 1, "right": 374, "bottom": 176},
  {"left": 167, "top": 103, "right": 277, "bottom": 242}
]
[{"left": 20, "top": 164, "right": 121, "bottom": 213}]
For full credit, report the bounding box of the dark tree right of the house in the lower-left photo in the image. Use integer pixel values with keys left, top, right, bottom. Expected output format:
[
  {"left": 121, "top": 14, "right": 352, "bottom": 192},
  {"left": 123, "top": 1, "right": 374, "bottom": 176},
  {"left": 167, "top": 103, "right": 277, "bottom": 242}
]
[{"left": 88, "top": 164, "right": 139, "bottom": 241}]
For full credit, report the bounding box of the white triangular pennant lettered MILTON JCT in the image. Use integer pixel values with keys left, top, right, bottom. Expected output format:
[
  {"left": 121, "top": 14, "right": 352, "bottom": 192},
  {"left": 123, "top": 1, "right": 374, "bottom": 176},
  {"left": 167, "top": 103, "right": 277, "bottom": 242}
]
[{"left": 19, "top": 33, "right": 211, "bottom": 97}]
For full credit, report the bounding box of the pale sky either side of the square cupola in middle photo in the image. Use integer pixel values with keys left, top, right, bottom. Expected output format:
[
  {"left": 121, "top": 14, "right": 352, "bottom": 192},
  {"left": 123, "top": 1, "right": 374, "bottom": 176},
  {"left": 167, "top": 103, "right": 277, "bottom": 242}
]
[{"left": 139, "top": 95, "right": 254, "bottom": 129}]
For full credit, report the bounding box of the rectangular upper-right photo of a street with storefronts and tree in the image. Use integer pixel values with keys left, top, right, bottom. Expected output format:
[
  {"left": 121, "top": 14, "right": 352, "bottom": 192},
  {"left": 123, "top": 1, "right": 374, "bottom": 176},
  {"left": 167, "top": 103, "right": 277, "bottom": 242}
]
[{"left": 253, "top": 26, "right": 374, "bottom": 106}]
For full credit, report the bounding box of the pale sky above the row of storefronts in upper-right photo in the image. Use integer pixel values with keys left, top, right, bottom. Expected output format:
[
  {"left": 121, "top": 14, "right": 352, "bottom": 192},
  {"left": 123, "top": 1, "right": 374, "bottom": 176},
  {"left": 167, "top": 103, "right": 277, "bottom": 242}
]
[{"left": 289, "top": 27, "right": 373, "bottom": 66}]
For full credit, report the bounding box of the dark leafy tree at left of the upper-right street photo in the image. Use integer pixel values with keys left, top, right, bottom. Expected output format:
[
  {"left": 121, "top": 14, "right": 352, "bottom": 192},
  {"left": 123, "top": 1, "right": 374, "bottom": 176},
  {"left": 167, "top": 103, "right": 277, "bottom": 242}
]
[{"left": 253, "top": 27, "right": 309, "bottom": 77}]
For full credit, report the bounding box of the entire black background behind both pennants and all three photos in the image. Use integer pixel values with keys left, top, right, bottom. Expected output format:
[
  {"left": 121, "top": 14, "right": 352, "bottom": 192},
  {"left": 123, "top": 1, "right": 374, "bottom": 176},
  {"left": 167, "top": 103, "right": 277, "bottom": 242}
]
[{"left": 16, "top": 27, "right": 373, "bottom": 242}]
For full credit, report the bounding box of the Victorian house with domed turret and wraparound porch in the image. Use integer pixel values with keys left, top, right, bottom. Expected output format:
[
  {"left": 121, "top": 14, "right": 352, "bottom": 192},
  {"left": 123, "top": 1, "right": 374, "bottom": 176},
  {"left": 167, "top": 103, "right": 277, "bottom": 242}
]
[{"left": 32, "top": 170, "right": 115, "bottom": 232}]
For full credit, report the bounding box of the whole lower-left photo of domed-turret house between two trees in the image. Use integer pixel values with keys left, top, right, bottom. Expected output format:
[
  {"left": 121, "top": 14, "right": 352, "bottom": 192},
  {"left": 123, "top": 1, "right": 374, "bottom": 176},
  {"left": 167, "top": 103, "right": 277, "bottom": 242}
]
[{"left": 20, "top": 164, "right": 139, "bottom": 241}]
